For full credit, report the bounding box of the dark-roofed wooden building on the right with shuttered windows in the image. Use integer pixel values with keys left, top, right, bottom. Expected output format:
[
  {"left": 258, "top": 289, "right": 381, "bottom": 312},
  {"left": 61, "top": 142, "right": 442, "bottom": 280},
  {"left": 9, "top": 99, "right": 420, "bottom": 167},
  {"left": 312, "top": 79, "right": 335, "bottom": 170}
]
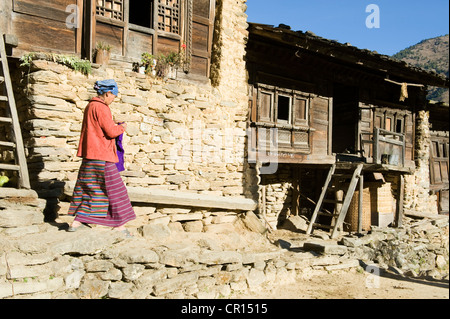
[{"left": 247, "top": 24, "right": 449, "bottom": 236}]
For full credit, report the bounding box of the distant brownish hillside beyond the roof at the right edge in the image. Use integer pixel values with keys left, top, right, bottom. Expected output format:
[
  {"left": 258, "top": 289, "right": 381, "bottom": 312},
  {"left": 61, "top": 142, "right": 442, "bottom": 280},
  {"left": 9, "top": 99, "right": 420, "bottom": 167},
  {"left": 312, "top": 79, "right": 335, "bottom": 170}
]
[{"left": 392, "top": 34, "right": 449, "bottom": 103}]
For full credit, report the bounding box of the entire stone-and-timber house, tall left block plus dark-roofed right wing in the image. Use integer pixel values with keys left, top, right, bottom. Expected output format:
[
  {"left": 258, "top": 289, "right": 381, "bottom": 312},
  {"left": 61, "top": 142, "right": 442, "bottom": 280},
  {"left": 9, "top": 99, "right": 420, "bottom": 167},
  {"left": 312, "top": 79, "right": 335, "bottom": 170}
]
[{"left": 0, "top": 0, "right": 448, "bottom": 235}]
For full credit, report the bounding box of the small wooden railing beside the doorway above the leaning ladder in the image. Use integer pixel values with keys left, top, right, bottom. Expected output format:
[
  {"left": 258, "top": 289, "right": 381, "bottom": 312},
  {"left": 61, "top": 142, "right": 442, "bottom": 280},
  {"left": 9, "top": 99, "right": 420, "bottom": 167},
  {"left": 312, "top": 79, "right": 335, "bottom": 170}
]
[{"left": 360, "top": 128, "right": 406, "bottom": 166}]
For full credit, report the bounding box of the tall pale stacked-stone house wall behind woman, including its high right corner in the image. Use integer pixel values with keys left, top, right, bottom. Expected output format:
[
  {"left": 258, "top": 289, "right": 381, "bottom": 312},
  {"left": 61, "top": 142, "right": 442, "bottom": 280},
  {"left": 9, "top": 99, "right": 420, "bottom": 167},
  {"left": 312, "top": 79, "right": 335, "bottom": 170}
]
[{"left": 1, "top": 0, "right": 254, "bottom": 226}]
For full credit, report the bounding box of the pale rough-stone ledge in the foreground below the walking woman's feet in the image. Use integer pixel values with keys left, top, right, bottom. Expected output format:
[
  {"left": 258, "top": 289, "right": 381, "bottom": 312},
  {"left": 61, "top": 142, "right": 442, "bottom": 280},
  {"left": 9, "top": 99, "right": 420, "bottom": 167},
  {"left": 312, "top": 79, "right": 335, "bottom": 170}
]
[{"left": 0, "top": 202, "right": 364, "bottom": 299}]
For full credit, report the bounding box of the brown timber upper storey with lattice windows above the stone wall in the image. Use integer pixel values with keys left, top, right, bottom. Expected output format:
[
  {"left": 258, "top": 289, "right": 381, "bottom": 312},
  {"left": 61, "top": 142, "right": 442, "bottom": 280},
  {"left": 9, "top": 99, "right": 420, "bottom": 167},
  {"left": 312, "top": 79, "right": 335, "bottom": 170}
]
[{"left": 0, "top": 0, "right": 215, "bottom": 77}]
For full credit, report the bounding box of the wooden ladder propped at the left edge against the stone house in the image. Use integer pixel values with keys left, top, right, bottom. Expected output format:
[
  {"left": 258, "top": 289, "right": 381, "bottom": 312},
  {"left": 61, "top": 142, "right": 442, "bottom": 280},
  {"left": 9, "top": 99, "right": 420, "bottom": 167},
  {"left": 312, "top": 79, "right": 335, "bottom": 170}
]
[{"left": 0, "top": 33, "right": 30, "bottom": 189}]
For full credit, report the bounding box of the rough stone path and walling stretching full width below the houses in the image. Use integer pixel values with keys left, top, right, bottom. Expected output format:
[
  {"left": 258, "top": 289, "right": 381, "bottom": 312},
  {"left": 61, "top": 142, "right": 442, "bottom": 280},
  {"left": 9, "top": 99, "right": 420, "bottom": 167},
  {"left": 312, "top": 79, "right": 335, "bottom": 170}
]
[{"left": 0, "top": 189, "right": 448, "bottom": 299}]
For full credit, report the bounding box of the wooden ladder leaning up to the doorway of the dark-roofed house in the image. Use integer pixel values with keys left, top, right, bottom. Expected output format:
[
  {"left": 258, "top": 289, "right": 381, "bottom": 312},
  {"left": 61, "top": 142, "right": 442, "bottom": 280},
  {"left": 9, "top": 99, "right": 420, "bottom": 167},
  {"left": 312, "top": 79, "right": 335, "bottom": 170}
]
[{"left": 306, "top": 164, "right": 363, "bottom": 238}]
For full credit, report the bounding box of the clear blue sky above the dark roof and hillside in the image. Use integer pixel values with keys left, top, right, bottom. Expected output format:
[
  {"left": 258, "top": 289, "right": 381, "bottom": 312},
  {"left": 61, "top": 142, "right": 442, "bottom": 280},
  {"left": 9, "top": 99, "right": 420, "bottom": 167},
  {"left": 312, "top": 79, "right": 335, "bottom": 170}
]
[{"left": 246, "top": 0, "right": 449, "bottom": 55}]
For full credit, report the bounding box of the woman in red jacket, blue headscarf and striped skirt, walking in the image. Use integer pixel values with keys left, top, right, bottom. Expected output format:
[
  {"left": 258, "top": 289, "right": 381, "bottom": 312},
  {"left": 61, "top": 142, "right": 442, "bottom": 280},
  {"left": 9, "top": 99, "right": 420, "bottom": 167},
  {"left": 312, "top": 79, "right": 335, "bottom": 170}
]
[{"left": 69, "top": 80, "right": 136, "bottom": 237}]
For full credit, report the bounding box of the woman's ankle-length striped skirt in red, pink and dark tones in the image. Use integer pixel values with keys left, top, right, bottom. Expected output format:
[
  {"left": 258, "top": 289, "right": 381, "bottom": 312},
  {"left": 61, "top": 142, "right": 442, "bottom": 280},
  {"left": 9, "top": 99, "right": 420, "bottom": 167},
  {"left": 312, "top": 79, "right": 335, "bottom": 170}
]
[{"left": 69, "top": 159, "right": 136, "bottom": 227}]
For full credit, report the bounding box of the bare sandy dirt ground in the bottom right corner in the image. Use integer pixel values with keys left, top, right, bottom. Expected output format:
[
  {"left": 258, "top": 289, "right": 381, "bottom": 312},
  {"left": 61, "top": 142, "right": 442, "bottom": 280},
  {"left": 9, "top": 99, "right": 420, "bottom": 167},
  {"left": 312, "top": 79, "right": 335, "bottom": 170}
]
[{"left": 235, "top": 270, "right": 449, "bottom": 299}]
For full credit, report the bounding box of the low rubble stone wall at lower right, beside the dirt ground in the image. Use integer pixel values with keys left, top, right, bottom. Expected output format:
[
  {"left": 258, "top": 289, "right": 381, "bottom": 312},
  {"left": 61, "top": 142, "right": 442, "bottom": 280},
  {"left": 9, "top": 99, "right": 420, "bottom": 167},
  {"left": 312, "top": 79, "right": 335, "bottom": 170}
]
[{"left": 341, "top": 216, "right": 449, "bottom": 279}]
